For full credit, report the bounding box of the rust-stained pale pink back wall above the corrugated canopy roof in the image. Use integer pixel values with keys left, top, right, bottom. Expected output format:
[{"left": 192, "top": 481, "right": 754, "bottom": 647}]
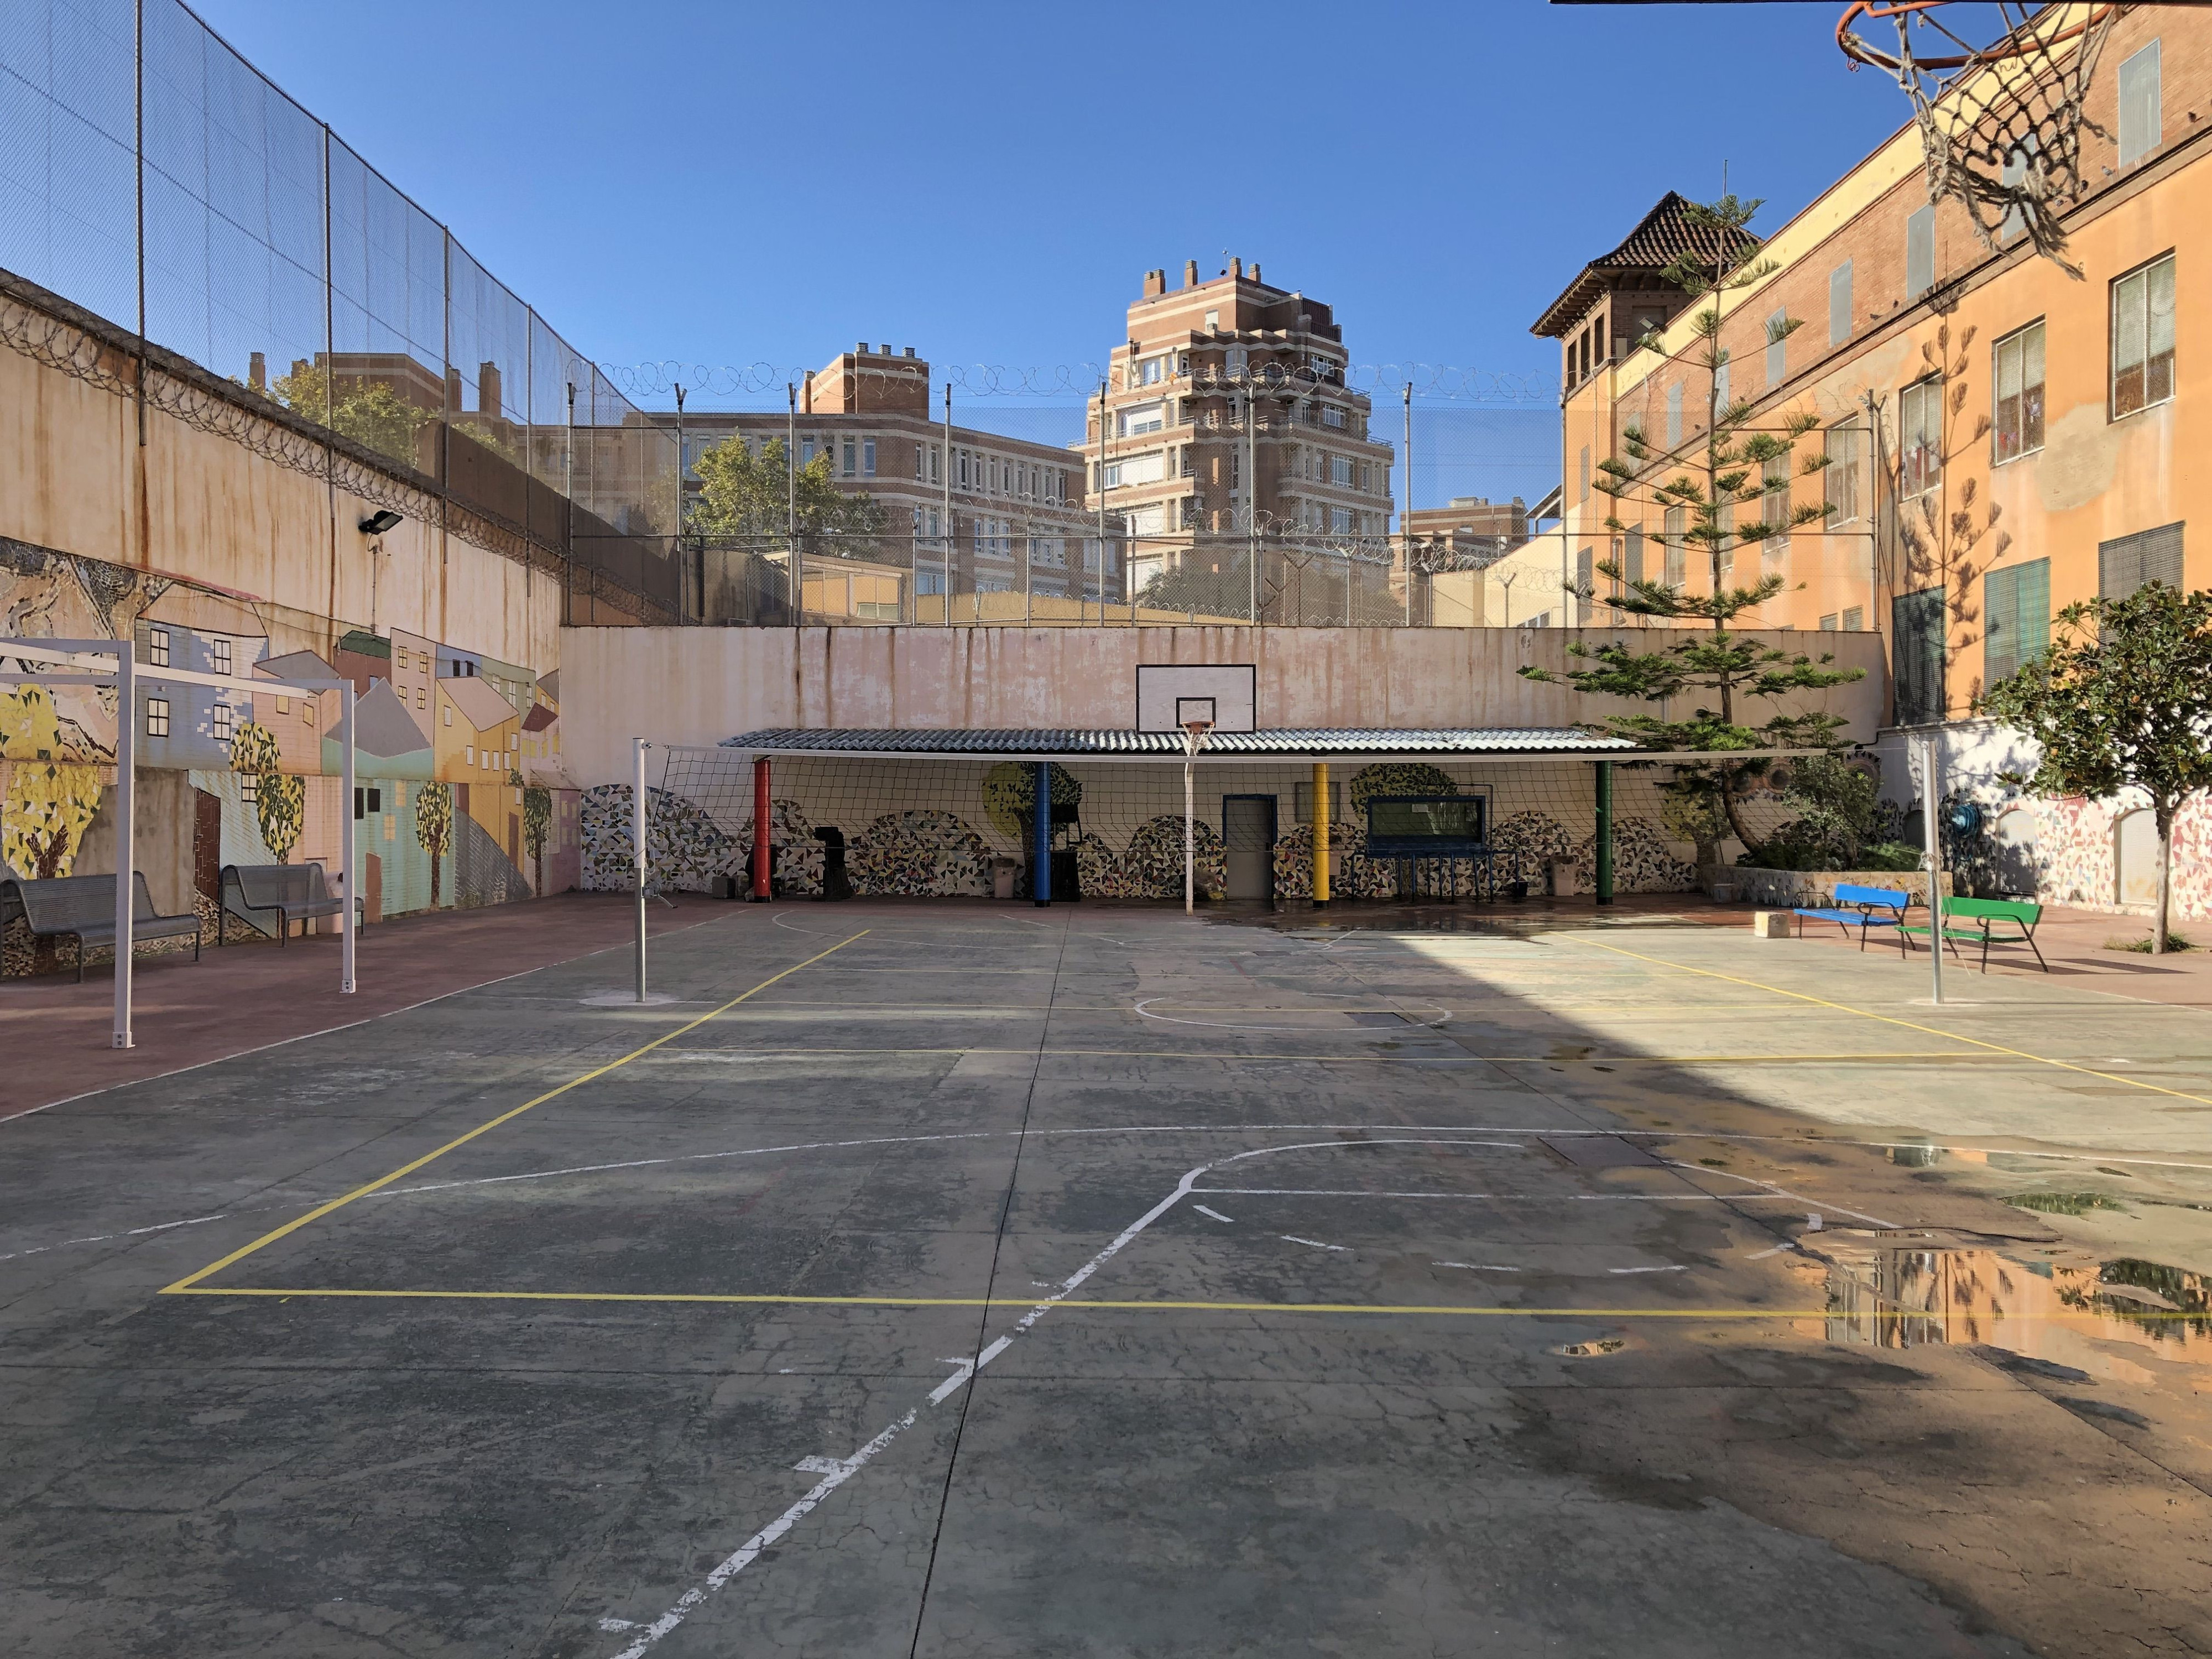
[{"left": 560, "top": 626, "right": 1887, "bottom": 787}]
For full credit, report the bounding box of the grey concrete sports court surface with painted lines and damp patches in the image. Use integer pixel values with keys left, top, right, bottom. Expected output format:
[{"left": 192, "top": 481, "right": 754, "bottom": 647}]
[{"left": 0, "top": 902, "right": 2212, "bottom": 1659}]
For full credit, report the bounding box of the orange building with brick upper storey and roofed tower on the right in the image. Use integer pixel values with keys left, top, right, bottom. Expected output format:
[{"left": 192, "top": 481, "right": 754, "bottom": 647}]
[{"left": 1515, "top": 7, "right": 2212, "bottom": 726}]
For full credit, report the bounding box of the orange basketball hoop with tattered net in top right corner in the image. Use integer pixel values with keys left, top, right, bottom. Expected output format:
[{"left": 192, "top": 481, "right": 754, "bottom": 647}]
[{"left": 1836, "top": 0, "right": 2121, "bottom": 276}]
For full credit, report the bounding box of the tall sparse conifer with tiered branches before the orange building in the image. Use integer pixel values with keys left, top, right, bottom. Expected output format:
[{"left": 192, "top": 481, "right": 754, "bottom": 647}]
[{"left": 1522, "top": 195, "right": 1865, "bottom": 858}]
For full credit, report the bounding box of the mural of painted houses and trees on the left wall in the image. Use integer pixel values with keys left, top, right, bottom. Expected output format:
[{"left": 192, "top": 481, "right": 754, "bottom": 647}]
[{"left": 0, "top": 542, "right": 580, "bottom": 971}]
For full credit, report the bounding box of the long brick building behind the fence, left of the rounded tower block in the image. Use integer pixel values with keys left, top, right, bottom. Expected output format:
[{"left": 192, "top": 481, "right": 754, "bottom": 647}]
[{"left": 653, "top": 341, "right": 1102, "bottom": 622}]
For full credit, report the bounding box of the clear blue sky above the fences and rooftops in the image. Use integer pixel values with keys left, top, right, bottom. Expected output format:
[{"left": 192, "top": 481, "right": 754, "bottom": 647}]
[{"left": 195, "top": 0, "right": 1907, "bottom": 498}]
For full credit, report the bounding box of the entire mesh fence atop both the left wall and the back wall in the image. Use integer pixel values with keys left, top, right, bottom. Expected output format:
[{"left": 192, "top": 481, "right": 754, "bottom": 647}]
[{"left": 0, "top": 0, "right": 1564, "bottom": 626}]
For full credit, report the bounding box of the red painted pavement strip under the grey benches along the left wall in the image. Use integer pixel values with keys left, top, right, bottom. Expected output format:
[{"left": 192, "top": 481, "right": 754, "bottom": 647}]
[{"left": 0, "top": 894, "right": 737, "bottom": 1121}]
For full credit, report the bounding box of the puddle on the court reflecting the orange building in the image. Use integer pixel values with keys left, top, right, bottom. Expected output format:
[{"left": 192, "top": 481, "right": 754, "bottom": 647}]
[{"left": 1820, "top": 1232, "right": 2212, "bottom": 1383}]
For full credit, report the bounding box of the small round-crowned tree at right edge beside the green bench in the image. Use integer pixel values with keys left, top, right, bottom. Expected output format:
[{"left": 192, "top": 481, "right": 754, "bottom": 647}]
[{"left": 1975, "top": 582, "right": 2212, "bottom": 953}]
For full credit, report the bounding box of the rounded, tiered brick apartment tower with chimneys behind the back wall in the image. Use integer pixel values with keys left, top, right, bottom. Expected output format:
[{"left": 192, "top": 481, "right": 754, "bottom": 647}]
[{"left": 1084, "top": 259, "right": 1391, "bottom": 619}]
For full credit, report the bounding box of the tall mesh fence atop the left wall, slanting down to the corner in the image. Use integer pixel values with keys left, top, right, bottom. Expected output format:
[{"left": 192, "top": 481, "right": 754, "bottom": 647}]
[{"left": 0, "top": 0, "right": 679, "bottom": 622}]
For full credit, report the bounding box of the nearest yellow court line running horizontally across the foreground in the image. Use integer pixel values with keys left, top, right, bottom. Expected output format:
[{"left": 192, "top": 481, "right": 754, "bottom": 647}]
[{"left": 161, "top": 1285, "right": 2203, "bottom": 1323}]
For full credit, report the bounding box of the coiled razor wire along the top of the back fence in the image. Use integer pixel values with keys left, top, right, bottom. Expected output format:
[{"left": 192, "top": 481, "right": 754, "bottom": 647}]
[{"left": 593, "top": 358, "right": 1562, "bottom": 407}]
